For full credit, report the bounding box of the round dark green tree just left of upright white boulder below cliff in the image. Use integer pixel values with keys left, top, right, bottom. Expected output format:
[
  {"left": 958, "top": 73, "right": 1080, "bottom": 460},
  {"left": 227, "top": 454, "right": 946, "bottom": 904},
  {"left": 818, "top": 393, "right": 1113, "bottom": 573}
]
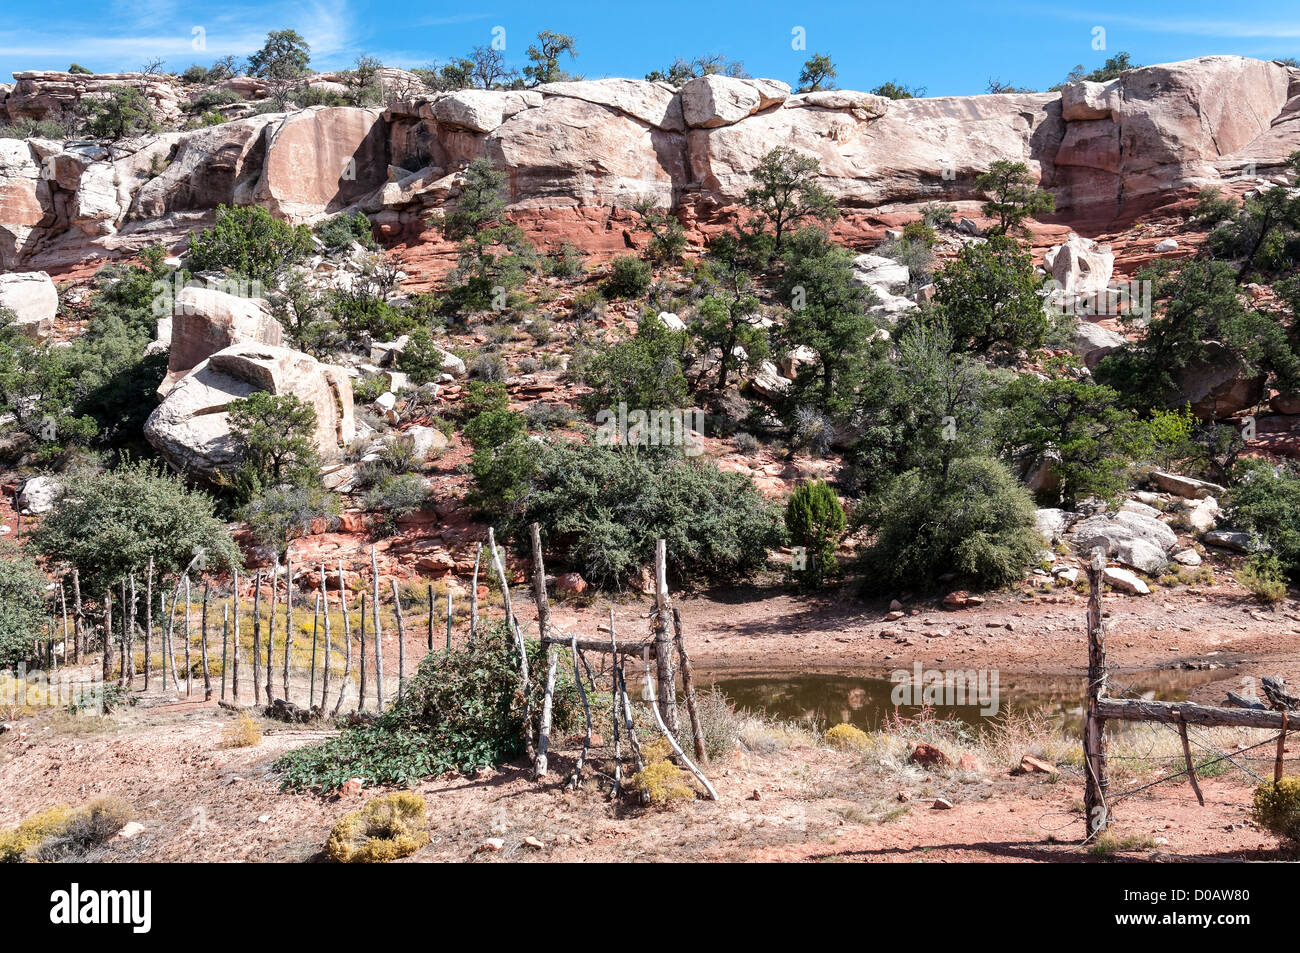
[{"left": 935, "top": 235, "right": 1049, "bottom": 359}]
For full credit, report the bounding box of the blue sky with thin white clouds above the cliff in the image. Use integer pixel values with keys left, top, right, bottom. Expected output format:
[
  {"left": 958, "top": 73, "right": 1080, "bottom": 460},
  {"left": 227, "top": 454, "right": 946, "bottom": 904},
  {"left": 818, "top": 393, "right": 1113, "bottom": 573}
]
[{"left": 0, "top": 0, "right": 1300, "bottom": 96}]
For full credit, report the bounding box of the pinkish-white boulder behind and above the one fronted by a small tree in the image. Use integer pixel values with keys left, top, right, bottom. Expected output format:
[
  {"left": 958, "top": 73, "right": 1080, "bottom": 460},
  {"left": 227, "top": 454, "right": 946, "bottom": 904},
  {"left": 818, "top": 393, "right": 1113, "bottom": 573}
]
[{"left": 159, "top": 286, "right": 283, "bottom": 397}]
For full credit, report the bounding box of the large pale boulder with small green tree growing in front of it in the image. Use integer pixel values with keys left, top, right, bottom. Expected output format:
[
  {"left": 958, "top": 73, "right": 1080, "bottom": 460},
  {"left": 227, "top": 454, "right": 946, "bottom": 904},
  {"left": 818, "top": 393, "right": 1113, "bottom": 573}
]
[{"left": 144, "top": 343, "right": 356, "bottom": 480}]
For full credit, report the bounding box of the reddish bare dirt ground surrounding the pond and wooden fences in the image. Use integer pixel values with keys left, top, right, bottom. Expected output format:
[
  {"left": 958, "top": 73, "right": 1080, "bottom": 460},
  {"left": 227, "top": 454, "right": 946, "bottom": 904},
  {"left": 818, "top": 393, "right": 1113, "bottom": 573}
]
[{"left": 0, "top": 572, "right": 1300, "bottom": 862}]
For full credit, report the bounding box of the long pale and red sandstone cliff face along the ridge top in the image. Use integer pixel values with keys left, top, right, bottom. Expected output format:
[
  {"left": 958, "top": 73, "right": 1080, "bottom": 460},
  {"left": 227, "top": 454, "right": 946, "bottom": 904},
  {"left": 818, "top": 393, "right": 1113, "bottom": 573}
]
[{"left": 0, "top": 56, "right": 1300, "bottom": 270}]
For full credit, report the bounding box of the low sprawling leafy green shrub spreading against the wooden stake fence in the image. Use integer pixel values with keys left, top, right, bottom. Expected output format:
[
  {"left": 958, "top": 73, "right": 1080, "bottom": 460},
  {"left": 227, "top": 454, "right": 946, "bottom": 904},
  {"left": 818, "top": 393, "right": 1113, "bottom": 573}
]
[{"left": 276, "top": 623, "right": 577, "bottom": 792}]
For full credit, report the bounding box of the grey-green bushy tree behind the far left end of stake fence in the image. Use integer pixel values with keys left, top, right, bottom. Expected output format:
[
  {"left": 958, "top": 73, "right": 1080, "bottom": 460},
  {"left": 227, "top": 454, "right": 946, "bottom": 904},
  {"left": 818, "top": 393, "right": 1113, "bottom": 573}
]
[{"left": 33, "top": 460, "right": 241, "bottom": 594}]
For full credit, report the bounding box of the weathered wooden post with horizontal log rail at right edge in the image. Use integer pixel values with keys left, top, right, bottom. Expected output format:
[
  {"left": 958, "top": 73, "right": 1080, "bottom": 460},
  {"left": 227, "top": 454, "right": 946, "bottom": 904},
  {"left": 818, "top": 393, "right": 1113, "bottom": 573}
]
[{"left": 1083, "top": 547, "right": 1300, "bottom": 840}]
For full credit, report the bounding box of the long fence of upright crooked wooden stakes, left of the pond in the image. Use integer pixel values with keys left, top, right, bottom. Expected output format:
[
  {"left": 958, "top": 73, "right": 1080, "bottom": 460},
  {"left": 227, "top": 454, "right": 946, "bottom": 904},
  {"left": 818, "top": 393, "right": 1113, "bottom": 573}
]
[{"left": 25, "top": 523, "right": 716, "bottom": 798}]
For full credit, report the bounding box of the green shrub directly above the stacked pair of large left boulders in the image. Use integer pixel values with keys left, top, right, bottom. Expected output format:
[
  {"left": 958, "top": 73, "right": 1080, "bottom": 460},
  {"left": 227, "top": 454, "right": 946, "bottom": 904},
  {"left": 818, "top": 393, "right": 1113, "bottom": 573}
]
[{"left": 190, "top": 205, "right": 312, "bottom": 285}]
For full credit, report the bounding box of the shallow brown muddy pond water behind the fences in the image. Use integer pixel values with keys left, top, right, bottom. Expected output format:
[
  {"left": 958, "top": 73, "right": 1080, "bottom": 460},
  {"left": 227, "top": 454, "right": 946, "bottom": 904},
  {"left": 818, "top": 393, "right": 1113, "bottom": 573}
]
[{"left": 696, "top": 670, "right": 1225, "bottom": 731}]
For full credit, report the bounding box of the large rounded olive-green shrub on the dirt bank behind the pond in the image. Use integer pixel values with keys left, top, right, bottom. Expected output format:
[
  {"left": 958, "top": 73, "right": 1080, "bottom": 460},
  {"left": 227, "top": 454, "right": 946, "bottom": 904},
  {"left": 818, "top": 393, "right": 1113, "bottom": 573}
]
[{"left": 862, "top": 456, "right": 1043, "bottom": 592}]
